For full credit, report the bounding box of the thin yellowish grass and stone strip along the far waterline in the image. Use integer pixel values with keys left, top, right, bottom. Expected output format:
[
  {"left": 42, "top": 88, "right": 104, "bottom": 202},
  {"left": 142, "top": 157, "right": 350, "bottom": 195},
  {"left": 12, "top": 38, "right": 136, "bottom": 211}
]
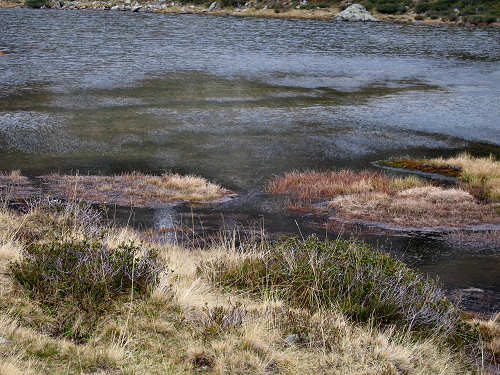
[{"left": 0, "top": 0, "right": 500, "bottom": 28}]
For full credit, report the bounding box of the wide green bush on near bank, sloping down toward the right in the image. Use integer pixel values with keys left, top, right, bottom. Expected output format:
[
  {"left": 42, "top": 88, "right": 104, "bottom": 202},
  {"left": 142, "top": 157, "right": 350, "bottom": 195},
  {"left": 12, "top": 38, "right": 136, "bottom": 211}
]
[{"left": 200, "top": 237, "right": 460, "bottom": 335}]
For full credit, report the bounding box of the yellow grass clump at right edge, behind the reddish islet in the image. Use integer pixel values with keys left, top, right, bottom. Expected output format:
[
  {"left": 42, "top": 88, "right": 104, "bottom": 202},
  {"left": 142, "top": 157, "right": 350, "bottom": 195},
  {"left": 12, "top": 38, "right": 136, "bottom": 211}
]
[{"left": 429, "top": 153, "right": 500, "bottom": 200}]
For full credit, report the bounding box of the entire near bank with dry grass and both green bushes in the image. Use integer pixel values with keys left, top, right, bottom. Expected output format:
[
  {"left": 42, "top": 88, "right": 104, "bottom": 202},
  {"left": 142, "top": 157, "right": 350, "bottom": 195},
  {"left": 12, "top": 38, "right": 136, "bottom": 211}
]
[{"left": 0, "top": 198, "right": 500, "bottom": 375}]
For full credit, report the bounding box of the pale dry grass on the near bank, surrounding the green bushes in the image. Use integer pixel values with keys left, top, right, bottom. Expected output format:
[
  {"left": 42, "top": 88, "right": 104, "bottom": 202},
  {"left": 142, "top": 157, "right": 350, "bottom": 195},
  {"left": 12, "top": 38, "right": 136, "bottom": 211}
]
[{"left": 0, "top": 201, "right": 494, "bottom": 375}]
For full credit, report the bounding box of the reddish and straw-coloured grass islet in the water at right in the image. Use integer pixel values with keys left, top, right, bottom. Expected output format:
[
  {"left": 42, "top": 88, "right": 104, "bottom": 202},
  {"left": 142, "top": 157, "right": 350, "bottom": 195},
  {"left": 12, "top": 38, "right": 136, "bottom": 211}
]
[{"left": 268, "top": 170, "right": 500, "bottom": 227}]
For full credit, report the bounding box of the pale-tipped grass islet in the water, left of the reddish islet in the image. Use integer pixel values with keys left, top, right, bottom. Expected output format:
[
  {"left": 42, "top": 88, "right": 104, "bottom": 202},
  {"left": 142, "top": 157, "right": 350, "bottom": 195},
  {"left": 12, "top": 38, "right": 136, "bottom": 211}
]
[{"left": 41, "top": 172, "right": 231, "bottom": 207}]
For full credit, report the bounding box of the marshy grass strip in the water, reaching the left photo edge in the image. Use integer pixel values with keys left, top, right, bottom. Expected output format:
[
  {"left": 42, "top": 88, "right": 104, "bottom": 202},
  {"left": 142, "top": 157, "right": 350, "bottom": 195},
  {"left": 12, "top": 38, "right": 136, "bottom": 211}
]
[{"left": 0, "top": 171, "right": 234, "bottom": 208}]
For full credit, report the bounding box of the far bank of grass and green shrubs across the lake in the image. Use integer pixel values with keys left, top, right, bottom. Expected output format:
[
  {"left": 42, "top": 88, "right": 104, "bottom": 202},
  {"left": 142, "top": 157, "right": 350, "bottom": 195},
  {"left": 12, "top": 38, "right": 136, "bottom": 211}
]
[{"left": 0, "top": 0, "right": 500, "bottom": 26}]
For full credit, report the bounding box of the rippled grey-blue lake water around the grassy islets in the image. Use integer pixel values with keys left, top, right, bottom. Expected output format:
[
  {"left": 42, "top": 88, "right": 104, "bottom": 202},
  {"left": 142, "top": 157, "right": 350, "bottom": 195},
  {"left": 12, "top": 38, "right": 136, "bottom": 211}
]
[{"left": 0, "top": 9, "right": 500, "bottom": 310}]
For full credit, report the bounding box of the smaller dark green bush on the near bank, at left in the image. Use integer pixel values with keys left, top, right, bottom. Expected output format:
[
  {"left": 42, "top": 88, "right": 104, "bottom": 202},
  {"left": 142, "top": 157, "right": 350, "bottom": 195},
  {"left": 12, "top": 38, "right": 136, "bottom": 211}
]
[{"left": 9, "top": 241, "right": 164, "bottom": 339}]
